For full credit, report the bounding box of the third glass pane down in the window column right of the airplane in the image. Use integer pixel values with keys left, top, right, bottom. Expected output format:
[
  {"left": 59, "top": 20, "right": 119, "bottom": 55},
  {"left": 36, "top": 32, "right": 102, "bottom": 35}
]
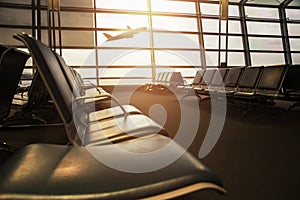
[{"left": 154, "top": 32, "right": 200, "bottom": 49}]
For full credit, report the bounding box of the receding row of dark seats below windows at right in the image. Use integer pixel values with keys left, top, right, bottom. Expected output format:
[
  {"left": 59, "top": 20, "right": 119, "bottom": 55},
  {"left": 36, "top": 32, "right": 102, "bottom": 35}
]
[{"left": 184, "top": 65, "right": 299, "bottom": 108}]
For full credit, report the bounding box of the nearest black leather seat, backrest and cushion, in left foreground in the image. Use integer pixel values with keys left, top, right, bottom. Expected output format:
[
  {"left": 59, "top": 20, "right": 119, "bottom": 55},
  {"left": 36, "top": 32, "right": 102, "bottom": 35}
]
[{"left": 0, "top": 34, "right": 225, "bottom": 199}]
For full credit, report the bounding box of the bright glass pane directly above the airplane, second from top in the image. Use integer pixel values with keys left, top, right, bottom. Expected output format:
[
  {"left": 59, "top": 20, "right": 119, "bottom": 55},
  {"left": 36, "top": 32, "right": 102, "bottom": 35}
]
[{"left": 97, "top": 13, "right": 148, "bottom": 29}]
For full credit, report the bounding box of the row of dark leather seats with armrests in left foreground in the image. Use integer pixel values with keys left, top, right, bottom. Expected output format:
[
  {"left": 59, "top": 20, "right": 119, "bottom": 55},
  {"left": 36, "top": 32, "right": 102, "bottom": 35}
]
[{"left": 0, "top": 33, "right": 226, "bottom": 199}]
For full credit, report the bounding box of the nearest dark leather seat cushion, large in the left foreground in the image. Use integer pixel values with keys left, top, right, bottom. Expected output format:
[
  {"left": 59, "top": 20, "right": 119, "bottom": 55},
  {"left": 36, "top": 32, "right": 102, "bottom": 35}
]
[{"left": 0, "top": 135, "right": 221, "bottom": 199}]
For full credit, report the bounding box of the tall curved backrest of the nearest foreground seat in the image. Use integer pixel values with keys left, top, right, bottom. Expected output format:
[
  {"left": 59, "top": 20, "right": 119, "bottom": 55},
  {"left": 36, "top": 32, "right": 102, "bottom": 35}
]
[{"left": 14, "top": 33, "right": 76, "bottom": 142}]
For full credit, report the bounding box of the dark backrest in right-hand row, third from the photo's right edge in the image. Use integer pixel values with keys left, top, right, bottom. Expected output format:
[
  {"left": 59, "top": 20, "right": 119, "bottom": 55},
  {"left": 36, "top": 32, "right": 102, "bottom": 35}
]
[{"left": 238, "top": 66, "right": 263, "bottom": 90}]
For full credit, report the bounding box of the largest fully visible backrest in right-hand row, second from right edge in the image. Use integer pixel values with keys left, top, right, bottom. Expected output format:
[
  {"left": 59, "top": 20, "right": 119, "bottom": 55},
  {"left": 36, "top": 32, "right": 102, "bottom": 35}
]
[{"left": 257, "top": 65, "right": 288, "bottom": 95}]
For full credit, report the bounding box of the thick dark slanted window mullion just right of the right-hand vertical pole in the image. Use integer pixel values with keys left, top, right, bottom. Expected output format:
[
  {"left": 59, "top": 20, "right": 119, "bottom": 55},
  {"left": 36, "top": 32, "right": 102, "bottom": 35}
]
[{"left": 239, "top": 0, "right": 251, "bottom": 66}]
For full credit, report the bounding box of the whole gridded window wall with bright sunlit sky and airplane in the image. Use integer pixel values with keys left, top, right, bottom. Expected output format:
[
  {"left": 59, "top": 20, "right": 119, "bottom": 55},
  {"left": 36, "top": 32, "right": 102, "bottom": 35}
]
[{"left": 0, "top": 0, "right": 300, "bottom": 85}]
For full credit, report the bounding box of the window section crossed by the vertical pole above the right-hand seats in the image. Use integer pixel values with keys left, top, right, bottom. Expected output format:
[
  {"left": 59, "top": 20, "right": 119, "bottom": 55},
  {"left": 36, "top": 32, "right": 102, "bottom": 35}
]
[{"left": 200, "top": 2, "right": 245, "bottom": 67}]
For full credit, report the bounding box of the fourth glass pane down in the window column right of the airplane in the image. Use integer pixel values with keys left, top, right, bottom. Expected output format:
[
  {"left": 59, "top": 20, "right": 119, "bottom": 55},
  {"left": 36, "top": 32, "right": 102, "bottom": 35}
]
[{"left": 155, "top": 50, "right": 201, "bottom": 66}]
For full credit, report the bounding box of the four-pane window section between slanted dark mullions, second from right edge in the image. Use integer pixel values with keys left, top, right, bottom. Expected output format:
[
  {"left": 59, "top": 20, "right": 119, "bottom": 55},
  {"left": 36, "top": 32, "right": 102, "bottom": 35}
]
[{"left": 245, "top": 6, "right": 285, "bottom": 65}]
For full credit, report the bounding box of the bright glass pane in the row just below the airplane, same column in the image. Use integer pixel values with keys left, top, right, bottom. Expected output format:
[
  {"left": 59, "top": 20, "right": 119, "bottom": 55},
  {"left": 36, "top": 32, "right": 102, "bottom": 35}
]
[{"left": 98, "top": 49, "right": 151, "bottom": 67}]
